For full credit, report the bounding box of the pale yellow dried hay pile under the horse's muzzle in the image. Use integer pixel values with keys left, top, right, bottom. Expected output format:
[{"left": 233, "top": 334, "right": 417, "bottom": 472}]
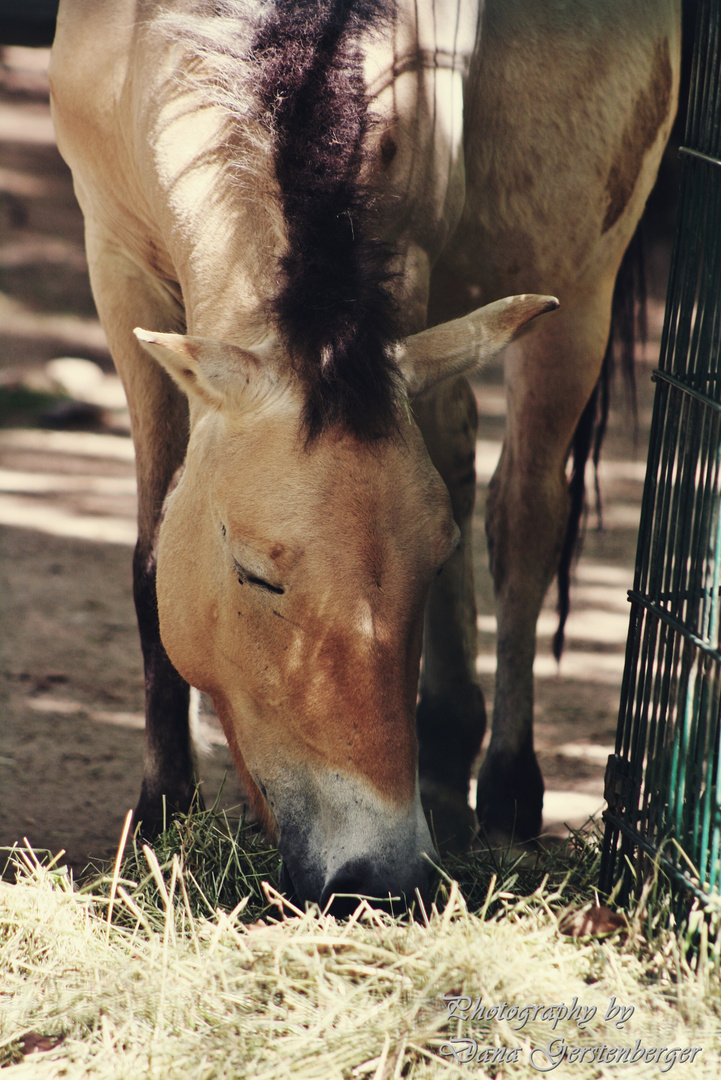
[{"left": 0, "top": 820, "right": 721, "bottom": 1080}]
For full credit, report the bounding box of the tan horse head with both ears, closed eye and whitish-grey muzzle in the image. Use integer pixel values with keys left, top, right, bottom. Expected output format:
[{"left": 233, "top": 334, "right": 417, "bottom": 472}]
[{"left": 136, "top": 297, "right": 556, "bottom": 905}]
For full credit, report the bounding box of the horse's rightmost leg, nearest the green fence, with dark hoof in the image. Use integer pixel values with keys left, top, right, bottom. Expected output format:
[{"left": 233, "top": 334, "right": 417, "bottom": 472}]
[{"left": 477, "top": 291, "right": 611, "bottom": 840}]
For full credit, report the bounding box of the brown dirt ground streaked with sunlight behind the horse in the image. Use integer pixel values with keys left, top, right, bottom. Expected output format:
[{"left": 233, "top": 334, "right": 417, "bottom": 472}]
[{"left": 0, "top": 49, "right": 663, "bottom": 869}]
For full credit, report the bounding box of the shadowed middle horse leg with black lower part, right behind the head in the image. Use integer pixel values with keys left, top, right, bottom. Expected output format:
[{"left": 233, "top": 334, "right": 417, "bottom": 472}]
[{"left": 413, "top": 378, "right": 486, "bottom": 849}]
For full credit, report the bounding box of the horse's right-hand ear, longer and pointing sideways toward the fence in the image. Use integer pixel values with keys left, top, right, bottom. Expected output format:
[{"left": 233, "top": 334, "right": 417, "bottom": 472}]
[{"left": 395, "top": 293, "right": 558, "bottom": 397}]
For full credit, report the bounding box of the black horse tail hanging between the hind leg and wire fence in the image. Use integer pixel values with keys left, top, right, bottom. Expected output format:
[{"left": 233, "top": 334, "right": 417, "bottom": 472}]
[{"left": 553, "top": 227, "right": 647, "bottom": 660}]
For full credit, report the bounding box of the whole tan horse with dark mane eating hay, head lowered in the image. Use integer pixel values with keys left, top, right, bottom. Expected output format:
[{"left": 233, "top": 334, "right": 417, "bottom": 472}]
[{"left": 51, "top": 0, "right": 679, "bottom": 903}]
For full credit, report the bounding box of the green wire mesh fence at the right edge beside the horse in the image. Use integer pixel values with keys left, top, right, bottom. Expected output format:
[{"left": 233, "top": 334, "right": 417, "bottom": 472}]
[{"left": 600, "top": 0, "right": 721, "bottom": 901}]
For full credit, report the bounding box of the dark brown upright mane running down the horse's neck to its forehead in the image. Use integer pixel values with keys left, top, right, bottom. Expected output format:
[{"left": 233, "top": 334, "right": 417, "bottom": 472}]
[{"left": 253, "top": 0, "right": 398, "bottom": 438}]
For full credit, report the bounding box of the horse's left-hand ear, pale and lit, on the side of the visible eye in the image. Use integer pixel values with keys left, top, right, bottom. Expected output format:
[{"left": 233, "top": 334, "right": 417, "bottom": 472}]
[{"left": 133, "top": 326, "right": 277, "bottom": 408}]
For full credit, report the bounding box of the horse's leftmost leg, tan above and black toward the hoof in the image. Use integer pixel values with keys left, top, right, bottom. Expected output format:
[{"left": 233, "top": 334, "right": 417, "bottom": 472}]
[{"left": 86, "top": 228, "right": 195, "bottom": 837}]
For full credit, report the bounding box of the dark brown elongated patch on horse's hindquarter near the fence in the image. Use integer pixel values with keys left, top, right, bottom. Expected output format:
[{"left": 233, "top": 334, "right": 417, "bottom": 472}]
[{"left": 601, "top": 39, "right": 674, "bottom": 233}]
